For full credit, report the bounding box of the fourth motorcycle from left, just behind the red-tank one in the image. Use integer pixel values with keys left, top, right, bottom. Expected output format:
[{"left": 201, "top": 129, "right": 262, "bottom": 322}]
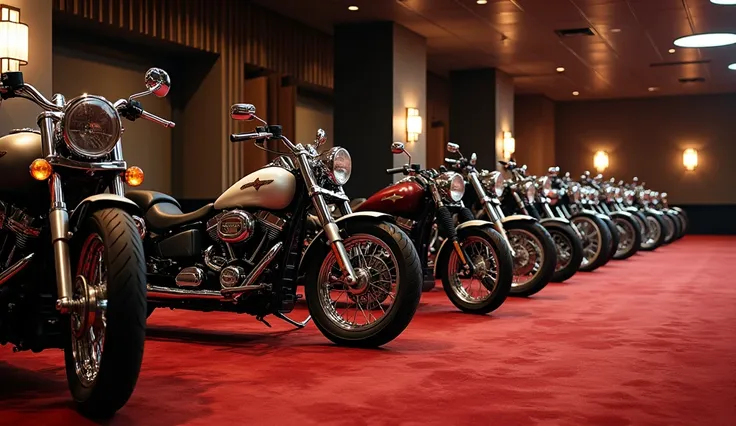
[{"left": 445, "top": 143, "right": 557, "bottom": 297}]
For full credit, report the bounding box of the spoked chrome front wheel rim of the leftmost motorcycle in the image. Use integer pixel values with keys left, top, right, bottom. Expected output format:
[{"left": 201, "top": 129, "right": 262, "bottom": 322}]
[{"left": 71, "top": 234, "right": 107, "bottom": 387}]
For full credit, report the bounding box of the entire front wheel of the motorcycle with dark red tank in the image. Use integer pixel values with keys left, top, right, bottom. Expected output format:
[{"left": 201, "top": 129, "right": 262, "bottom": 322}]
[{"left": 437, "top": 226, "right": 514, "bottom": 314}]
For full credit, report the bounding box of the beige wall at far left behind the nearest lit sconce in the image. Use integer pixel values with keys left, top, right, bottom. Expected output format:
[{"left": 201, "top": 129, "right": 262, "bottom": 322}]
[{"left": 0, "top": 0, "right": 52, "bottom": 135}]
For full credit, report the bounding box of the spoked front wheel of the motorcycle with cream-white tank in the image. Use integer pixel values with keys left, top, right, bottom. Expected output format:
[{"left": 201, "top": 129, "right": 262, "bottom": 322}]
[{"left": 305, "top": 221, "right": 422, "bottom": 347}]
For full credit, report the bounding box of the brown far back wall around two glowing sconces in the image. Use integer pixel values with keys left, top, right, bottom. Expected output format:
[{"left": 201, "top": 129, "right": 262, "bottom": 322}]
[{"left": 555, "top": 94, "right": 736, "bottom": 204}]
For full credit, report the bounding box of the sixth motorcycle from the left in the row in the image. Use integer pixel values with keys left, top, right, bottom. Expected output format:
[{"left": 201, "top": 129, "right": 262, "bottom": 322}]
[{"left": 543, "top": 166, "right": 613, "bottom": 272}]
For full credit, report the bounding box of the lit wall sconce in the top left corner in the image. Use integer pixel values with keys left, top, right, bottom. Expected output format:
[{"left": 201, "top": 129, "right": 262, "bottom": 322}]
[{"left": 0, "top": 4, "right": 28, "bottom": 72}]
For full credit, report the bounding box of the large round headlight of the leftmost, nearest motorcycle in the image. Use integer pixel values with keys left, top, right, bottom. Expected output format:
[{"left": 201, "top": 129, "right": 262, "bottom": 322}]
[{"left": 61, "top": 95, "right": 123, "bottom": 158}]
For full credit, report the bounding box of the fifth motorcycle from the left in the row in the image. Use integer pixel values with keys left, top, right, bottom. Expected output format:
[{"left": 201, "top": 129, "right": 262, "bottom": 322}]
[{"left": 501, "top": 161, "right": 583, "bottom": 283}]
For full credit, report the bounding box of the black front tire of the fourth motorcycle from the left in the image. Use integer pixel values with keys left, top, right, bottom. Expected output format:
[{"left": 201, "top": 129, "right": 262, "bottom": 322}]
[{"left": 503, "top": 220, "right": 557, "bottom": 297}]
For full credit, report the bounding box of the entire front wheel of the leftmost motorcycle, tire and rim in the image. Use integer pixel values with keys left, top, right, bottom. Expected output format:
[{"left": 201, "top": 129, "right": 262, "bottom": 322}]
[{"left": 64, "top": 208, "right": 146, "bottom": 418}]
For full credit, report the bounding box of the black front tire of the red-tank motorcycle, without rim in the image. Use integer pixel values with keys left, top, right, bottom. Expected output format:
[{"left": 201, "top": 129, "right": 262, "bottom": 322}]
[{"left": 437, "top": 226, "right": 514, "bottom": 314}]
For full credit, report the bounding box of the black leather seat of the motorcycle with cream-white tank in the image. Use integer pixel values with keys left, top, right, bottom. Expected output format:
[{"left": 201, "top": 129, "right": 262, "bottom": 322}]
[{"left": 125, "top": 190, "right": 215, "bottom": 232}]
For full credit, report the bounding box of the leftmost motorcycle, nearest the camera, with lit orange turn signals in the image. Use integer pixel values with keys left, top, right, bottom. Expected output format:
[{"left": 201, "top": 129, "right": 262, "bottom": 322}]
[{"left": 0, "top": 68, "right": 174, "bottom": 418}]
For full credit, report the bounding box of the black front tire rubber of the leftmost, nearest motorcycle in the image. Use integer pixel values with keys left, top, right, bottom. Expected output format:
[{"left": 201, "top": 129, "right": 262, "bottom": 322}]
[{"left": 64, "top": 208, "right": 147, "bottom": 418}]
